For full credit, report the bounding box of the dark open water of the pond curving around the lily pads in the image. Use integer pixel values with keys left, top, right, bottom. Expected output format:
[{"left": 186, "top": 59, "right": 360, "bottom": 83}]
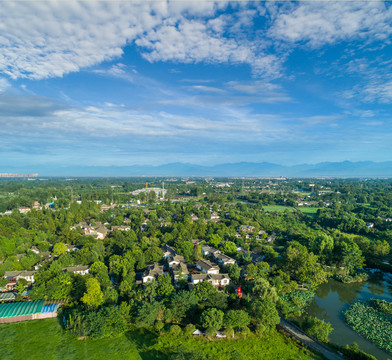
[{"left": 308, "top": 278, "right": 392, "bottom": 360}]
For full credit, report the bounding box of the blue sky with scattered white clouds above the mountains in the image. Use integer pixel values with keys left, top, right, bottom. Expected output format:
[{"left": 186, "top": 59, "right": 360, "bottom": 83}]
[{"left": 0, "top": 0, "right": 392, "bottom": 174}]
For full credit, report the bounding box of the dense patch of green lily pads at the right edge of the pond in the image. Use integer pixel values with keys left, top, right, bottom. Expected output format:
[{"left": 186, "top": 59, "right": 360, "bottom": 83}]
[{"left": 344, "top": 299, "right": 392, "bottom": 353}]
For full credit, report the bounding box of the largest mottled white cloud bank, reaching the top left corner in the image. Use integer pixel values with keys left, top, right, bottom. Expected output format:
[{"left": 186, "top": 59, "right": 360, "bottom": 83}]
[{"left": 0, "top": 0, "right": 281, "bottom": 79}]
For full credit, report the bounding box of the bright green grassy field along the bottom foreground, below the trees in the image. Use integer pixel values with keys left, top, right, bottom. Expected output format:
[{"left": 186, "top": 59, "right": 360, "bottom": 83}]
[{"left": 0, "top": 319, "right": 321, "bottom": 360}]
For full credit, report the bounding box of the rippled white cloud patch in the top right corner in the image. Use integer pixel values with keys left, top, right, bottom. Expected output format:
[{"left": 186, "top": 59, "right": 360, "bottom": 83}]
[{"left": 269, "top": 1, "right": 392, "bottom": 47}]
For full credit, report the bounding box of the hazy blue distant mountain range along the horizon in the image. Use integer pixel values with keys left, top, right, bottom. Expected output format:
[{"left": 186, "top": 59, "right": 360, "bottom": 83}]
[{"left": 32, "top": 161, "right": 392, "bottom": 177}]
